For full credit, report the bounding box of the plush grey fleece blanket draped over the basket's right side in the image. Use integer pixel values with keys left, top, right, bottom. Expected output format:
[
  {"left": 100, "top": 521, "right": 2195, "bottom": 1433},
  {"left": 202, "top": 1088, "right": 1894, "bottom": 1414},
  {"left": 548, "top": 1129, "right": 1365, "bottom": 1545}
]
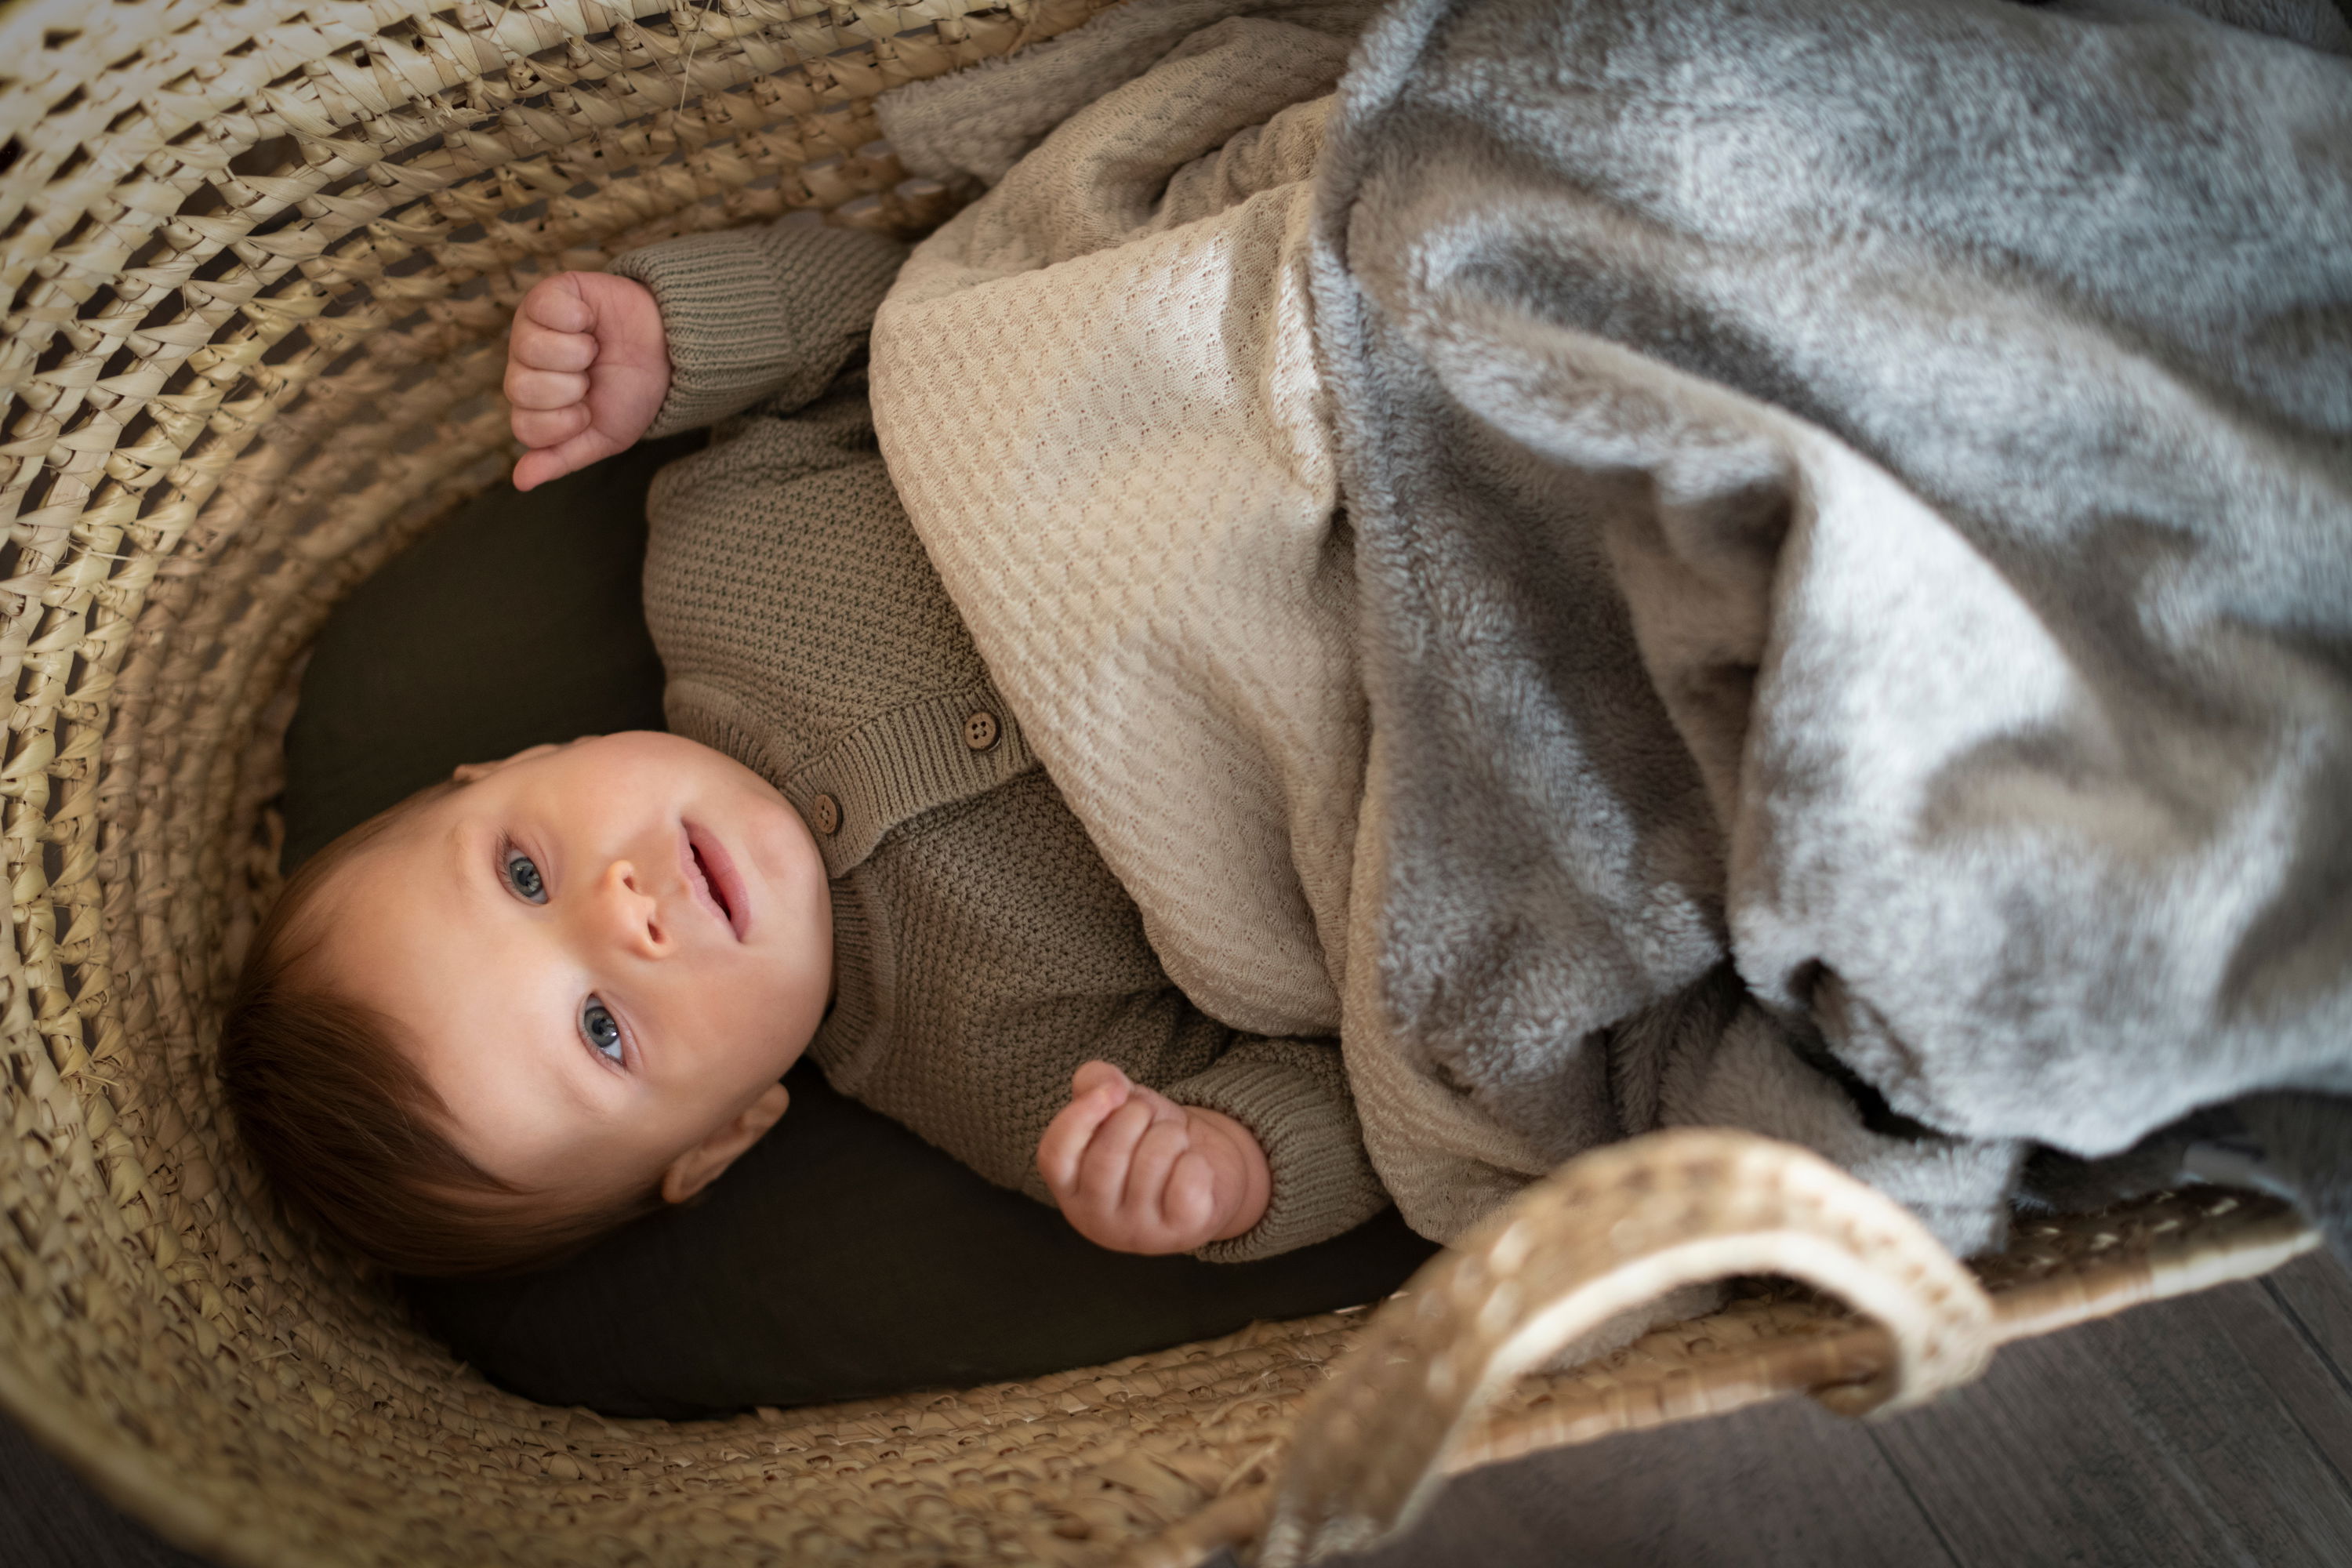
[{"left": 1315, "top": 0, "right": 2352, "bottom": 1246}]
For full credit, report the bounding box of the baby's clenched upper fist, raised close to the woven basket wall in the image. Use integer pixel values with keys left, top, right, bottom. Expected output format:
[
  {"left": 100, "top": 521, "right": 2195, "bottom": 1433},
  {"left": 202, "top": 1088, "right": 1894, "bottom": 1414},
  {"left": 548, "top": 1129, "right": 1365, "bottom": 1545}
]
[{"left": 506, "top": 273, "right": 670, "bottom": 489}]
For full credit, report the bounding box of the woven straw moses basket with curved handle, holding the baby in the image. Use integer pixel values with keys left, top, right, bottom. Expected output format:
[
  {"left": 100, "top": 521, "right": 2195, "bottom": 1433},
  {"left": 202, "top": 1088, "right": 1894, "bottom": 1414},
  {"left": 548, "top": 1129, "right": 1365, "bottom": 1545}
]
[{"left": 0, "top": 0, "right": 2310, "bottom": 1566}]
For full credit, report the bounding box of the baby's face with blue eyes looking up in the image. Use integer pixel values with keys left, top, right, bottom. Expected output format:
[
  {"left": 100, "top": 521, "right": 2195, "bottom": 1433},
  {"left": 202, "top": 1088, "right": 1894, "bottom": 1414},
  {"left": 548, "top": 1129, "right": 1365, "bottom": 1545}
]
[{"left": 320, "top": 731, "right": 833, "bottom": 1199}]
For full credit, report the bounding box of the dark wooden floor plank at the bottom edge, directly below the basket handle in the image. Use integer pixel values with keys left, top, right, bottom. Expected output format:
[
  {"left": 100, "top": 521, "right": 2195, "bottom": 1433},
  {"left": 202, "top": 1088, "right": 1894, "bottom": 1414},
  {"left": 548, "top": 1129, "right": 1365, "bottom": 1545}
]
[{"left": 1341, "top": 1399, "right": 1957, "bottom": 1568}]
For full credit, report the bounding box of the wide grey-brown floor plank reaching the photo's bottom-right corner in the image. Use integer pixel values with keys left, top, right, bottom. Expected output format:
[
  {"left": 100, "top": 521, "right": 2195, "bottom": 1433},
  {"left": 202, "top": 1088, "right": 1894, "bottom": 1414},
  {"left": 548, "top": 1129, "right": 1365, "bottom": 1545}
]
[{"left": 1877, "top": 1283, "right": 2352, "bottom": 1568}]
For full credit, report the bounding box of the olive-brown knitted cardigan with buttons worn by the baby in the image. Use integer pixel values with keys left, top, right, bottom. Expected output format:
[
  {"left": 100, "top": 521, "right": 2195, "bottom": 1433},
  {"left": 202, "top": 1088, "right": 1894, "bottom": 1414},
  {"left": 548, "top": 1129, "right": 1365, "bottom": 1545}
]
[{"left": 626, "top": 226, "right": 1388, "bottom": 1260}]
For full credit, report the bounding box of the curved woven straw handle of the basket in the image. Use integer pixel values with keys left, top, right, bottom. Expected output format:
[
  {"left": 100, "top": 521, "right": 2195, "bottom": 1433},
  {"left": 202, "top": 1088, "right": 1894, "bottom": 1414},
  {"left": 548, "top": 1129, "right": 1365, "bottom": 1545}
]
[{"left": 1256, "top": 1128, "right": 1994, "bottom": 1568}]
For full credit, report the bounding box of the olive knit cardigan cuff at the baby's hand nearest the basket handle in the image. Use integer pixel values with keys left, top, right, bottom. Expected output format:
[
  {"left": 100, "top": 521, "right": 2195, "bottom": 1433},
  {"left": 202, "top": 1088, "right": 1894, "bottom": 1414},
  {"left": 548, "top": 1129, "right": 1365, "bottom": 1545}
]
[{"left": 1162, "top": 1039, "right": 1388, "bottom": 1262}]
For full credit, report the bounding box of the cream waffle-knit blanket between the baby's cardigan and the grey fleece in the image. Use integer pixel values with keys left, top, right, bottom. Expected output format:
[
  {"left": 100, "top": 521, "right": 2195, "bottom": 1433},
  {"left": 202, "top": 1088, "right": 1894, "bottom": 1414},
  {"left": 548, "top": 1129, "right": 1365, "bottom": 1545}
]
[{"left": 875, "top": 7, "right": 1364, "bottom": 1034}]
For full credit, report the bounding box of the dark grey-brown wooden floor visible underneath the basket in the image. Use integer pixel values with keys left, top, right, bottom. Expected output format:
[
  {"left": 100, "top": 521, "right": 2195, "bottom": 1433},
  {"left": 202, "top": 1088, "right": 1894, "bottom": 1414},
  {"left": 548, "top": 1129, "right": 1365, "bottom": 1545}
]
[{"left": 0, "top": 1258, "right": 2352, "bottom": 1568}]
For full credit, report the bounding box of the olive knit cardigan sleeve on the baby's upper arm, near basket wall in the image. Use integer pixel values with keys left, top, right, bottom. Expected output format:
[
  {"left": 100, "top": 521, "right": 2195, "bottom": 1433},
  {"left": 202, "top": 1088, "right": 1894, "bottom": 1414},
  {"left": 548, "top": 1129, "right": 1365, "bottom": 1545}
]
[{"left": 607, "top": 214, "right": 906, "bottom": 440}]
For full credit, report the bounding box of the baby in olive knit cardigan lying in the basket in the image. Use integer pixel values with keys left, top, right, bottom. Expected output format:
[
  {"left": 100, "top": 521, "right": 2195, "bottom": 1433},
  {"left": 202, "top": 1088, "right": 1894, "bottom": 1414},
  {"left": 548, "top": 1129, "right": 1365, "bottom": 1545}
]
[{"left": 221, "top": 221, "right": 1385, "bottom": 1274}]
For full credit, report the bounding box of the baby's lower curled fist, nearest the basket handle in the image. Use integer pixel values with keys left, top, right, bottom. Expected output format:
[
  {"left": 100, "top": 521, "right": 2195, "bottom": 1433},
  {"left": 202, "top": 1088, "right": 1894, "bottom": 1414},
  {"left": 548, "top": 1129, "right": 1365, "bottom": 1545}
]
[{"left": 1037, "top": 1062, "right": 1272, "bottom": 1253}]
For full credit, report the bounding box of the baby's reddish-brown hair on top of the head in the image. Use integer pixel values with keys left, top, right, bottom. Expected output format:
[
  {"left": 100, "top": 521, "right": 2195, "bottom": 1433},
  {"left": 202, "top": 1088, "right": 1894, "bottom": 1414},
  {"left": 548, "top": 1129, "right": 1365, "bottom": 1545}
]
[{"left": 221, "top": 783, "right": 661, "bottom": 1274}]
